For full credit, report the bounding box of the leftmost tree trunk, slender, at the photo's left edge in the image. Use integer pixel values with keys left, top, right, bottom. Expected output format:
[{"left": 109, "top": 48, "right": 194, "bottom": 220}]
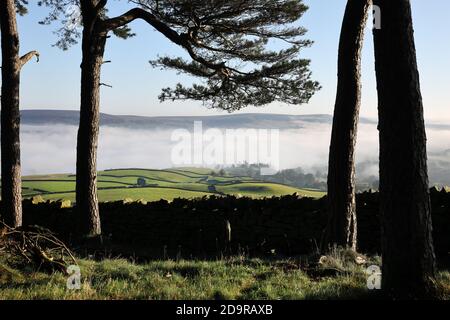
[{"left": 0, "top": 0, "right": 22, "bottom": 227}]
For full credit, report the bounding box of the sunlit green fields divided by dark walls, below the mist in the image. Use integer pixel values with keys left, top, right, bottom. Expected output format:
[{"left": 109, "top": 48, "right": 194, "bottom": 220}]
[{"left": 22, "top": 168, "right": 324, "bottom": 201}]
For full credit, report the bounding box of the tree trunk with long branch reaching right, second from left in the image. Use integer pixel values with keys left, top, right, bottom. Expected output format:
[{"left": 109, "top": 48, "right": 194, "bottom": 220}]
[{"left": 76, "top": 14, "right": 106, "bottom": 236}]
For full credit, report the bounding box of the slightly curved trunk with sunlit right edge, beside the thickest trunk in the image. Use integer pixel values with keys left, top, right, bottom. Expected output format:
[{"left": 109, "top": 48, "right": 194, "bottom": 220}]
[{"left": 322, "top": 0, "right": 372, "bottom": 250}]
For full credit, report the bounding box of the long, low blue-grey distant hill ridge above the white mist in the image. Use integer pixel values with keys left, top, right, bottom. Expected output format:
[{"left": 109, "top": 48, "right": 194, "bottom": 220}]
[{"left": 21, "top": 110, "right": 375, "bottom": 129}]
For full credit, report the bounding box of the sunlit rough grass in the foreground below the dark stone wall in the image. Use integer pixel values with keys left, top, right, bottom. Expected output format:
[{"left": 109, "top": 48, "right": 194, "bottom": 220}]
[{"left": 0, "top": 252, "right": 450, "bottom": 300}]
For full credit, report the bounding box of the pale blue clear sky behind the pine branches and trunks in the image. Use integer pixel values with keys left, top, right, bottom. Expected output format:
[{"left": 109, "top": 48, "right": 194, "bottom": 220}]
[{"left": 9, "top": 0, "right": 450, "bottom": 122}]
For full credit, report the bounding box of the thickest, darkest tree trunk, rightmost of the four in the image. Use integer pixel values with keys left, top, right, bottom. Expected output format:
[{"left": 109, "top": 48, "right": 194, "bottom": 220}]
[{"left": 374, "top": 0, "right": 435, "bottom": 297}]
